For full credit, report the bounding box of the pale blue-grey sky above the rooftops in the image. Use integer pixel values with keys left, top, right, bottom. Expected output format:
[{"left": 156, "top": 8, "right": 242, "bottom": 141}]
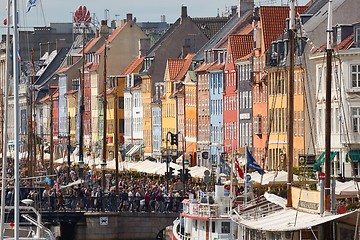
[{"left": 0, "top": 0, "right": 309, "bottom": 32}]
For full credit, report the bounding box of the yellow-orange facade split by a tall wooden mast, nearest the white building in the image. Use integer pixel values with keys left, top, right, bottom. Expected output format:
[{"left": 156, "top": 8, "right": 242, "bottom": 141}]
[{"left": 268, "top": 68, "right": 305, "bottom": 170}]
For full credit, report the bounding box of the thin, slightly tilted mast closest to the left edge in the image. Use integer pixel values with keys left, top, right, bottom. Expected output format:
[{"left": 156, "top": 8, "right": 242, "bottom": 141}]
[{"left": 0, "top": 0, "right": 11, "bottom": 240}]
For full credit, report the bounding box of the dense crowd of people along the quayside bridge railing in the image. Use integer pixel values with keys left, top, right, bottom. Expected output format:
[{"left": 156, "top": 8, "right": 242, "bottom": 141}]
[{"left": 2, "top": 162, "right": 202, "bottom": 213}]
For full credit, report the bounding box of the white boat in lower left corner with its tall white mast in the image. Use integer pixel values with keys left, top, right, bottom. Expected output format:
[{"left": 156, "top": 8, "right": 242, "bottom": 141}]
[{"left": 0, "top": 0, "right": 55, "bottom": 240}]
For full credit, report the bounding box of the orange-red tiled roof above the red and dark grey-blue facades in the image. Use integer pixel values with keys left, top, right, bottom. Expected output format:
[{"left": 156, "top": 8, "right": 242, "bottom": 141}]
[{"left": 229, "top": 35, "right": 254, "bottom": 61}]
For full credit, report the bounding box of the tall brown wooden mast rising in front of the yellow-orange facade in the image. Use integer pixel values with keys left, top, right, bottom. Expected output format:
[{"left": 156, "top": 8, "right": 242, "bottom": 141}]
[{"left": 286, "top": 0, "right": 295, "bottom": 207}]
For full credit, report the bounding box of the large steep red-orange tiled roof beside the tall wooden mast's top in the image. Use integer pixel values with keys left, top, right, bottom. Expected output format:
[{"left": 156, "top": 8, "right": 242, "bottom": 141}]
[{"left": 260, "top": 6, "right": 308, "bottom": 50}]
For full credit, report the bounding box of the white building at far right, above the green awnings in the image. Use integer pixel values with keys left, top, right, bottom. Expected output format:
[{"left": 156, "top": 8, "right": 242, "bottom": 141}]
[{"left": 310, "top": 23, "right": 360, "bottom": 178}]
